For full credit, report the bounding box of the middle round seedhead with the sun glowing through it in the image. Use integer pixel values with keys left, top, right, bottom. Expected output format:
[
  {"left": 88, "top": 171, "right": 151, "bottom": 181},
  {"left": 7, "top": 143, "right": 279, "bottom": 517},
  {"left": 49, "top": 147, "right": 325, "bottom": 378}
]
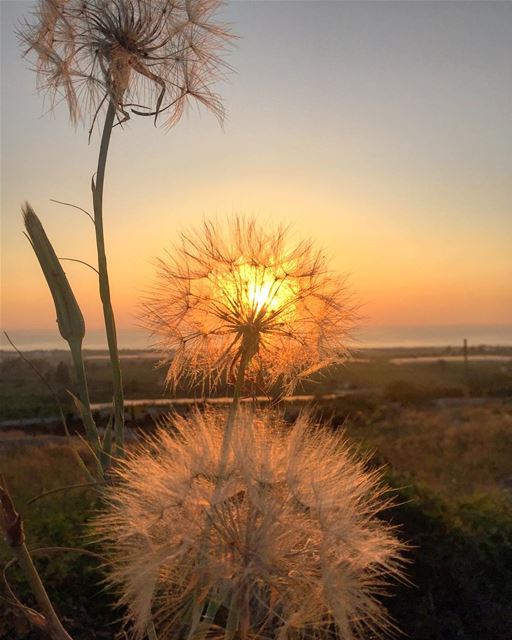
[{"left": 143, "top": 218, "right": 353, "bottom": 392}]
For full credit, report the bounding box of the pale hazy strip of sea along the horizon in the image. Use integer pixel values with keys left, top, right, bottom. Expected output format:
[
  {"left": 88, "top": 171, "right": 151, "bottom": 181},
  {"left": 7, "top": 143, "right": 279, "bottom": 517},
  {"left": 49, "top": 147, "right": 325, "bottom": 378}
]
[{"left": 0, "top": 325, "right": 512, "bottom": 351}]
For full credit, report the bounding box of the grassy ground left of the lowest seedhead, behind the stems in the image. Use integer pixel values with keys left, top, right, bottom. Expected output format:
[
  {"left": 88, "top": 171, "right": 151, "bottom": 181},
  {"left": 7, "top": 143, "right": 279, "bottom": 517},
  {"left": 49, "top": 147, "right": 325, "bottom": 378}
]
[{"left": 0, "top": 443, "right": 109, "bottom": 640}]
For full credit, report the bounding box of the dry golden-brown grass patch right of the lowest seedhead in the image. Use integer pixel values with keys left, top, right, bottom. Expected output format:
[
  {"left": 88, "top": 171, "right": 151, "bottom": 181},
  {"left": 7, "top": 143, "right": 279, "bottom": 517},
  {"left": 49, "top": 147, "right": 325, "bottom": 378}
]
[{"left": 358, "top": 402, "right": 512, "bottom": 496}]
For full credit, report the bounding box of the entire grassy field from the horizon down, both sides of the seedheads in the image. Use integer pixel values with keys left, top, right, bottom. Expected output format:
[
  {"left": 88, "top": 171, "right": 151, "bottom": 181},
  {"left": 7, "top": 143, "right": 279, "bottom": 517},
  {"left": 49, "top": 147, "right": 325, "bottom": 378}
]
[{"left": 0, "top": 353, "right": 512, "bottom": 640}]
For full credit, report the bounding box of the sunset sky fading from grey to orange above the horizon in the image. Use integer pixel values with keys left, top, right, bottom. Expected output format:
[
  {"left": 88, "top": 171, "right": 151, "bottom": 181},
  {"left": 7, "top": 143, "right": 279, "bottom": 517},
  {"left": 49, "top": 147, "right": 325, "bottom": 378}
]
[{"left": 0, "top": 0, "right": 512, "bottom": 344}]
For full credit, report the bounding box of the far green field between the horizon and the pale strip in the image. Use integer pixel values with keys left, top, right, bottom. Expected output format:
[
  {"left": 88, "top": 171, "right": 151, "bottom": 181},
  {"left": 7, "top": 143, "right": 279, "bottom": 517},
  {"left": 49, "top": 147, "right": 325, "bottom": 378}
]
[{"left": 0, "top": 347, "right": 512, "bottom": 421}]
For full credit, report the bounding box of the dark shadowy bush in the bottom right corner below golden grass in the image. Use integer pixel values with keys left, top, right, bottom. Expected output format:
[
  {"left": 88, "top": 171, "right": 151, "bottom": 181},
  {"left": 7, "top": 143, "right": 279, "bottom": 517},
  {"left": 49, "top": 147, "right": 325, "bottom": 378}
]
[{"left": 387, "top": 477, "right": 512, "bottom": 640}]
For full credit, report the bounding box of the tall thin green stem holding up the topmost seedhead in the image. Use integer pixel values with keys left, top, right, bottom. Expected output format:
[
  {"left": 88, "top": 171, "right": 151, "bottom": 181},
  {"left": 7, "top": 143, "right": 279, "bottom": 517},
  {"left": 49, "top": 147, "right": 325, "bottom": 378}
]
[{"left": 93, "top": 102, "right": 124, "bottom": 453}]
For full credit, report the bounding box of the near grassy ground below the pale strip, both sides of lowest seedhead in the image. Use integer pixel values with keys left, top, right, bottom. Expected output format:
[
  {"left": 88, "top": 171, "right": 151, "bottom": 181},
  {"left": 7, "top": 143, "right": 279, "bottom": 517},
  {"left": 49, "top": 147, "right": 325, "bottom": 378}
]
[{"left": 0, "top": 401, "right": 512, "bottom": 640}]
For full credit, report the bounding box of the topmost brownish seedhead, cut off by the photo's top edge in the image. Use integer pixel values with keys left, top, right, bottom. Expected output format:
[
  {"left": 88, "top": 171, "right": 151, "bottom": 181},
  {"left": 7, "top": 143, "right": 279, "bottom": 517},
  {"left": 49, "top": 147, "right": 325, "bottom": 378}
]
[{"left": 19, "top": 0, "right": 229, "bottom": 125}]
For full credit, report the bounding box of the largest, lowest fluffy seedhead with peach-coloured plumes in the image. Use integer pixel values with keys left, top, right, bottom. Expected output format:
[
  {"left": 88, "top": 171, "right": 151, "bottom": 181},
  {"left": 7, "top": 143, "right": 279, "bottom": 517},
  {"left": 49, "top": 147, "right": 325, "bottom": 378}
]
[{"left": 93, "top": 412, "right": 403, "bottom": 640}]
